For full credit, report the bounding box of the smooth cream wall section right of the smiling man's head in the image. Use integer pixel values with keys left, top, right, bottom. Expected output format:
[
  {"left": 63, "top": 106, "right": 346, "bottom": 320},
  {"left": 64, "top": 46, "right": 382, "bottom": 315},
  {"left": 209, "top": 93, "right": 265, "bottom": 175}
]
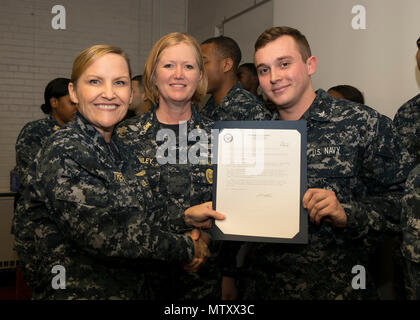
[{"left": 273, "top": 0, "right": 420, "bottom": 118}]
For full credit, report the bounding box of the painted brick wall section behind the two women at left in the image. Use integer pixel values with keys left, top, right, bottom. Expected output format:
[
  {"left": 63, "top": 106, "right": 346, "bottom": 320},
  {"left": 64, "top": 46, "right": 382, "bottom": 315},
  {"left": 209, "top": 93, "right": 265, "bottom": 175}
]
[{"left": 0, "top": 0, "right": 188, "bottom": 192}]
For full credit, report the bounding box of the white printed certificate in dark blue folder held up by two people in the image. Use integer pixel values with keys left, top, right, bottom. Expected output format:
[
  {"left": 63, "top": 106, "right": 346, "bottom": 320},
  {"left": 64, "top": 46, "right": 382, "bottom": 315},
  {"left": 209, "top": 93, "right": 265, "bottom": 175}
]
[{"left": 214, "top": 121, "right": 307, "bottom": 242}]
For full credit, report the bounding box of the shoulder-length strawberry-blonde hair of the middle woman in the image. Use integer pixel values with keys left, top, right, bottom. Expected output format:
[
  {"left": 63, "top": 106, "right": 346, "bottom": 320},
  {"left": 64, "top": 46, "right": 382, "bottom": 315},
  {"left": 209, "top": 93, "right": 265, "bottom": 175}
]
[{"left": 143, "top": 32, "right": 207, "bottom": 104}]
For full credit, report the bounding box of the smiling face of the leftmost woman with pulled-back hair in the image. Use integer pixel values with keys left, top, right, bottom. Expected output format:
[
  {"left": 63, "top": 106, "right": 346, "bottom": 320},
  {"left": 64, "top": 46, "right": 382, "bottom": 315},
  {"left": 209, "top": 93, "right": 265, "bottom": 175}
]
[{"left": 69, "top": 53, "right": 131, "bottom": 141}]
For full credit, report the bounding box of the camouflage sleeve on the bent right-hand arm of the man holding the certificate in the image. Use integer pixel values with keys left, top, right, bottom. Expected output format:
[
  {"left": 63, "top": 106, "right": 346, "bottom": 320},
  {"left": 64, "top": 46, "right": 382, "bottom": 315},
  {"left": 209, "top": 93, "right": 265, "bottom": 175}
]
[{"left": 342, "top": 116, "right": 413, "bottom": 240}]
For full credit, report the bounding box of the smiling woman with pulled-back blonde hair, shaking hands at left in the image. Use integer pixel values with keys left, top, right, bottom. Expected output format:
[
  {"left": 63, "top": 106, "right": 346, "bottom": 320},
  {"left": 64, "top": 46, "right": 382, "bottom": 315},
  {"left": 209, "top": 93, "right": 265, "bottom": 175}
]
[{"left": 15, "top": 45, "right": 223, "bottom": 299}]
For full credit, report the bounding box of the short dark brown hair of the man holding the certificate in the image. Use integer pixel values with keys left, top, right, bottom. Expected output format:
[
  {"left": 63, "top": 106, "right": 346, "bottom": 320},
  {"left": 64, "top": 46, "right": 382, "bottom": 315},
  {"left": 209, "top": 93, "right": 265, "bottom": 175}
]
[{"left": 254, "top": 26, "right": 312, "bottom": 62}]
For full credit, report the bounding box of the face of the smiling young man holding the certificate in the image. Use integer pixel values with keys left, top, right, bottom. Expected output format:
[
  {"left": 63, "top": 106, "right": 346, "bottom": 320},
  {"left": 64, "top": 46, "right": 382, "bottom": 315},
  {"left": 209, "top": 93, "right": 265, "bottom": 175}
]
[{"left": 254, "top": 35, "right": 316, "bottom": 113}]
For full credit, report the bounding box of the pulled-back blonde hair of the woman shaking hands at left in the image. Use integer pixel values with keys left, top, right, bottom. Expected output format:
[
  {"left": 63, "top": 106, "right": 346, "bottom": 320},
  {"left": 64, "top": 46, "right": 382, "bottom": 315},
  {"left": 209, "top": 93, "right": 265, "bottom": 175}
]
[{"left": 70, "top": 44, "right": 131, "bottom": 84}]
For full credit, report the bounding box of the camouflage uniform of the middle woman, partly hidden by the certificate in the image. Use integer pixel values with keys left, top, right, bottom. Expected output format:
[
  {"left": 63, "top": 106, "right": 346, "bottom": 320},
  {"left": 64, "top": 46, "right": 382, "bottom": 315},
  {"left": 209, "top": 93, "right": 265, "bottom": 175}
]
[{"left": 116, "top": 105, "right": 221, "bottom": 299}]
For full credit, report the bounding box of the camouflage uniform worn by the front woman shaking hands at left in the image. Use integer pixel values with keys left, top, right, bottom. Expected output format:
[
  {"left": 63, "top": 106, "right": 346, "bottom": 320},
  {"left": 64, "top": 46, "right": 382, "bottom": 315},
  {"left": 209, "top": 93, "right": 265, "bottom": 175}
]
[{"left": 13, "top": 114, "right": 194, "bottom": 299}]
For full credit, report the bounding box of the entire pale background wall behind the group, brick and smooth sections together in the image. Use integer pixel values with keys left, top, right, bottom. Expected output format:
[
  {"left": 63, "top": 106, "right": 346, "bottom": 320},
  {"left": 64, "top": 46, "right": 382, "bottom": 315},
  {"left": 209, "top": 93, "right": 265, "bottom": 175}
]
[{"left": 0, "top": 0, "right": 420, "bottom": 192}]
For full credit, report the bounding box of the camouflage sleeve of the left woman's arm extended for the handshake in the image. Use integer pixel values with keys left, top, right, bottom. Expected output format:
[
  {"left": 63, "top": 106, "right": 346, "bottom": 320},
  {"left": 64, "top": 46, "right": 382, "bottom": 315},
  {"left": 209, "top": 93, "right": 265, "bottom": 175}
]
[{"left": 33, "top": 146, "right": 194, "bottom": 261}]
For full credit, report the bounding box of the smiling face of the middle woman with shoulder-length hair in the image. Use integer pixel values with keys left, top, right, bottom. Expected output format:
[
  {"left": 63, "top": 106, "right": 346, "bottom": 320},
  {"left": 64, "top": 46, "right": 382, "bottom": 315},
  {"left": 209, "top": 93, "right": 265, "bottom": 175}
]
[{"left": 154, "top": 43, "right": 202, "bottom": 105}]
